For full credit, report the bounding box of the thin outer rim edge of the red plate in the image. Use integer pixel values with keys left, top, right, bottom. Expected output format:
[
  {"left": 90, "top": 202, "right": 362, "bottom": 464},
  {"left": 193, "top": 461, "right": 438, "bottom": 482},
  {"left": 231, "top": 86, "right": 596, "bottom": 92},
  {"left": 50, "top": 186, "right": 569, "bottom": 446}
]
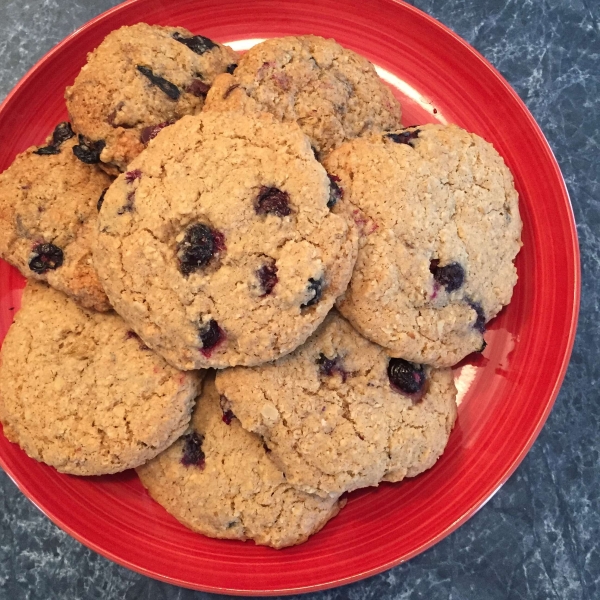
[{"left": 0, "top": 0, "right": 581, "bottom": 596}]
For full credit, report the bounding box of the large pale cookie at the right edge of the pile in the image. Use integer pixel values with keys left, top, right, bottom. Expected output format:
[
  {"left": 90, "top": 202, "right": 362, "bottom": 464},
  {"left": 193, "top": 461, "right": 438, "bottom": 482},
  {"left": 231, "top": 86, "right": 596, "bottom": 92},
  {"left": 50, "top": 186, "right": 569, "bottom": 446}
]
[{"left": 324, "top": 125, "right": 522, "bottom": 366}]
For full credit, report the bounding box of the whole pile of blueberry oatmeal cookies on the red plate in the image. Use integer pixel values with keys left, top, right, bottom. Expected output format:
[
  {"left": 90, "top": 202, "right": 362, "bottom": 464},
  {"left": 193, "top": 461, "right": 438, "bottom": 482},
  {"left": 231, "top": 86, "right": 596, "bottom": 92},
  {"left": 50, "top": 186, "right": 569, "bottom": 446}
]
[{"left": 0, "top": 24, "right": 521, "bottom": 548}]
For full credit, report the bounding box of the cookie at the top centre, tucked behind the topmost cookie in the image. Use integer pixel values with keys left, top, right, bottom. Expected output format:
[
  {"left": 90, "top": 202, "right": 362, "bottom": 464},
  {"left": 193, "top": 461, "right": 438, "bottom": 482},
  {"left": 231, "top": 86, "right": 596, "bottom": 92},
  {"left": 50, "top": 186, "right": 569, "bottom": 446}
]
[{"left": 205, "top": 35, "right": 401, "bottom": 157}]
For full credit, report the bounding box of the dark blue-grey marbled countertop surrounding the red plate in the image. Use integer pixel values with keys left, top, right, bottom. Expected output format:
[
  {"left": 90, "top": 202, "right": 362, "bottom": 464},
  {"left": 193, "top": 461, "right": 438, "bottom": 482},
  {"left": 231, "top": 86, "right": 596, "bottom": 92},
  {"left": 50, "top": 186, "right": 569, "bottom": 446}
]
[{"left": 0, "top": 0, "right": 600, "bottom": 600}]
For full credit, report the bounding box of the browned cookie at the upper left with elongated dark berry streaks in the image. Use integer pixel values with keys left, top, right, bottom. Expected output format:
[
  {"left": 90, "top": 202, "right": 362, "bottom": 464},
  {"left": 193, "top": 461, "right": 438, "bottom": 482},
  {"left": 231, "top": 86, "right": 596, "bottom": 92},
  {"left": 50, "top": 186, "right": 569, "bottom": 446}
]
[{"left": 65, "top": 23, "right": 238, "bottom": 175}]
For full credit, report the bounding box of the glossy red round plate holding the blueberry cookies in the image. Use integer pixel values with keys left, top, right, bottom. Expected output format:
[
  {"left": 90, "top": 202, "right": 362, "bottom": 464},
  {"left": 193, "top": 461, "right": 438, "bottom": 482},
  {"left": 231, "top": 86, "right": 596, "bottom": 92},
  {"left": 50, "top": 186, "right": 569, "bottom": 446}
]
[{"left": 0, "top": 0, "right": 579, "bottom": 595}]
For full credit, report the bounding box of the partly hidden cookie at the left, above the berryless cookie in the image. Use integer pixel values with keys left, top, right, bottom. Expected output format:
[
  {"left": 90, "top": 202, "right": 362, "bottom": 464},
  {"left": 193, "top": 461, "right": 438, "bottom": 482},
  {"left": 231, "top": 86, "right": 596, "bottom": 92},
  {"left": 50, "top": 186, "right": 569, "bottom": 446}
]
[{"left": 0, "top": 122, "right": 112, "bottom": 311}]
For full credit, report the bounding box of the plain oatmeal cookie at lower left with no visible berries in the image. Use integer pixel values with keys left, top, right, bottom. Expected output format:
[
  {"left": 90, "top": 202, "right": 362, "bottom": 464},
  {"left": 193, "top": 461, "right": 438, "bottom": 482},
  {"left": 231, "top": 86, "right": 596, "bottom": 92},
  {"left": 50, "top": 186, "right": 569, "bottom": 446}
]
[{"left": 0, "top": 281, "right": 200, "bottom": 475}]
